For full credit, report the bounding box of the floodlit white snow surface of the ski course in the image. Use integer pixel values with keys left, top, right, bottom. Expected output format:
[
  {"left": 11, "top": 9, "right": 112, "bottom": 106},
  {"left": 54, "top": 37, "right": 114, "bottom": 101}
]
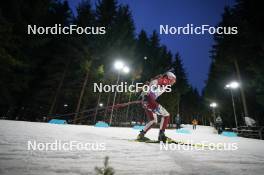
[{"left": 0, "top": 120, "right": 264, "bottom": 175}]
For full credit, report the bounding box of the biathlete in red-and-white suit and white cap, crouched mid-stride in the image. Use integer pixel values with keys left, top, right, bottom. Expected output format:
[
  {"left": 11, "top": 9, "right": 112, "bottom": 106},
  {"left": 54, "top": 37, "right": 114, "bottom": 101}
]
[{"left": 137, "top": 71, "right": 176, "bottom": 142}]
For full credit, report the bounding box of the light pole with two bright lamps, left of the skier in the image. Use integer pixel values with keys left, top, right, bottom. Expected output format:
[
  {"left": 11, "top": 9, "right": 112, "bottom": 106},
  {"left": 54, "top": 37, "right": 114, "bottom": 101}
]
[{"left": 109, "top": 61, "right": 130, "bottom": 125}]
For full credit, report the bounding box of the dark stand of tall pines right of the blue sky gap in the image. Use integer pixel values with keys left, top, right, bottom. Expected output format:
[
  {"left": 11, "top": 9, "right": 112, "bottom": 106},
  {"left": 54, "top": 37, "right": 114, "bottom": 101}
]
[{"left": 205, "top": 0, "right": 264, "bottom": 124}]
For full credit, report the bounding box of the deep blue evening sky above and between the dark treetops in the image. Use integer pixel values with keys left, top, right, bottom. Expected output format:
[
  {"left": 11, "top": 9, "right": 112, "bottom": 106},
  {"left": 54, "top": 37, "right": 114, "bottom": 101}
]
[{"left": 69, "top": 0, "right": 234, "bottom": 91}]
